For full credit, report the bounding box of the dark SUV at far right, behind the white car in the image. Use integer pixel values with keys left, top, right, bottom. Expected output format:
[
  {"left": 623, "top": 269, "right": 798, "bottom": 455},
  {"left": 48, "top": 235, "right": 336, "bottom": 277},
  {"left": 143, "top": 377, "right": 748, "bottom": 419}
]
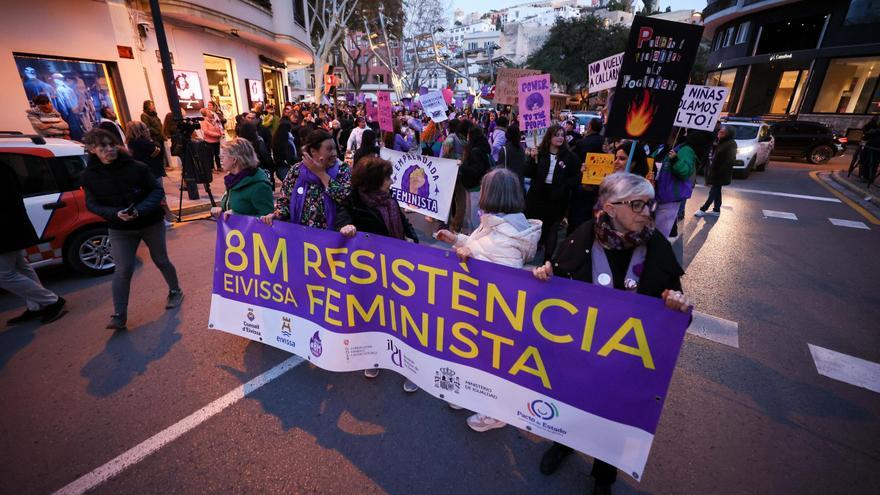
[{"left": 770, "top": 120, "right": 847, "bottom": 164}]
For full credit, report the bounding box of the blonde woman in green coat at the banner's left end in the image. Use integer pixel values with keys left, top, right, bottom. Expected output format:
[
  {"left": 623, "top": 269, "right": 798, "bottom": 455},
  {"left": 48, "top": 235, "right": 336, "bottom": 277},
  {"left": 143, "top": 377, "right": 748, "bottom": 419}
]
[{"left": 211, "top": 138, "right": 275, "bottom": 217}]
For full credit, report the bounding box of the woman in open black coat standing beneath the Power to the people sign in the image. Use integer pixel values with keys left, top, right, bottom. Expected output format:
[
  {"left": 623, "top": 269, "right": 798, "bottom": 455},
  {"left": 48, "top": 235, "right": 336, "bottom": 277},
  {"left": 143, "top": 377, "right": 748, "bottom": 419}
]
[{"left": 525, "top": 125, "right": 581, "bottom": 261}]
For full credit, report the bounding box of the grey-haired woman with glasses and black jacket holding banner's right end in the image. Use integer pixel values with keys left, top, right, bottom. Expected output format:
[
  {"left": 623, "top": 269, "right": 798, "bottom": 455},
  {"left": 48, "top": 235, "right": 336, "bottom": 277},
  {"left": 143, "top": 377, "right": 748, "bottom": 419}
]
[{"left": 533, "top": 172, "right": 692, "bottom": 493}]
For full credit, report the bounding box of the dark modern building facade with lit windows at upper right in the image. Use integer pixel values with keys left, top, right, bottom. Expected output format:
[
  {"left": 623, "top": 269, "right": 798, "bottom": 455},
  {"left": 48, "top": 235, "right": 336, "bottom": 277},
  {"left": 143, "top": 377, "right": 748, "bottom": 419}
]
[{"left": 703, "top": 0, "right": 880, "bottom": 131}]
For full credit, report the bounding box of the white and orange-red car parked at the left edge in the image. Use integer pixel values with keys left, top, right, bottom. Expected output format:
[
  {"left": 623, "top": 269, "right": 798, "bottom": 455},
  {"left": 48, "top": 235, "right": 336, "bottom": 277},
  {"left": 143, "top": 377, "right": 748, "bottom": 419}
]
[{"left": 0, "top": 132, "right": 115, "bottom": 275}]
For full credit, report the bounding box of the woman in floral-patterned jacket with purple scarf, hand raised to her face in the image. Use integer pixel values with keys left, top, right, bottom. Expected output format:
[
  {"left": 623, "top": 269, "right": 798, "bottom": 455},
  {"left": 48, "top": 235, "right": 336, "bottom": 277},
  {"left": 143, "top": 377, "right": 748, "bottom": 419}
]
[{"left": 260, "top": 130, "right": 357, "bottom": 237}]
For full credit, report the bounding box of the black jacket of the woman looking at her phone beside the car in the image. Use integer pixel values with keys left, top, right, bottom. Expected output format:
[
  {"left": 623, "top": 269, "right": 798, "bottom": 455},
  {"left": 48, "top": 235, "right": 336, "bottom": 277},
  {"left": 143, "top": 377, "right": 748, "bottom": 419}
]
[{"left": 81, "top": 152, "right": 165, "bottom": 230}]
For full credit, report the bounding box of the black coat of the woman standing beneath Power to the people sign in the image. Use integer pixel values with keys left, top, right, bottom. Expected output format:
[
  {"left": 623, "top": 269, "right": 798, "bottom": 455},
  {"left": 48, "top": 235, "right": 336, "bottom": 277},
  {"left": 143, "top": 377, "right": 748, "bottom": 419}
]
[{"left": 526, "top": 147, "right": 581, "bottom": 221}]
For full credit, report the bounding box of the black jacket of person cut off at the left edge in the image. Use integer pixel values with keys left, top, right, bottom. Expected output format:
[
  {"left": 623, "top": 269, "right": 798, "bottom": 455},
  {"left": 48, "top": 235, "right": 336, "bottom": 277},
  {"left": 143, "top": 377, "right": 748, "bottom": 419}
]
[{"left": 0, "top": 162, "right": 38, "bottom": 253}]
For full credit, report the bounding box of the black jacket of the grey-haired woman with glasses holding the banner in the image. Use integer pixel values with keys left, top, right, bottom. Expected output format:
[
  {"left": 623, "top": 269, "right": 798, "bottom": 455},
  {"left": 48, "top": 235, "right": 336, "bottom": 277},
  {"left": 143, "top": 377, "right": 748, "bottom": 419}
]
[{"left": 553, "top": 220, "right": 684, "bottom": 298}]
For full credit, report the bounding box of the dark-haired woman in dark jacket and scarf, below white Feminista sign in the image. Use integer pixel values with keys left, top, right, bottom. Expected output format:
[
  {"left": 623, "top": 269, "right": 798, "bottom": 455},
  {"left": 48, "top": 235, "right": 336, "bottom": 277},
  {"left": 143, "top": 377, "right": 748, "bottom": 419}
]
[{"left": 345, "top": 157, "right": 419, "bottom": 393}]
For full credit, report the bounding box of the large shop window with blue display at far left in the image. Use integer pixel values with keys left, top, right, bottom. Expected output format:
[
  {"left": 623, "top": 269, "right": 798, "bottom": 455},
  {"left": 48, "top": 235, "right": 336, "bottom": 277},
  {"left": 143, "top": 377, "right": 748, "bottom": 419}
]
[{"left": 14, "top": 54, "right": 126, "bottom": 141}]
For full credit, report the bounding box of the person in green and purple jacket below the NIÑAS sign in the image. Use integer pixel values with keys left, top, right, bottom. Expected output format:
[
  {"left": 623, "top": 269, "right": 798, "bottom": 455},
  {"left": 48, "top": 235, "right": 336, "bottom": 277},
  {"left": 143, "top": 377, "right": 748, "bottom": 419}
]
[{"left": 654, "top": 135, "right": 697, "bottom": 237}]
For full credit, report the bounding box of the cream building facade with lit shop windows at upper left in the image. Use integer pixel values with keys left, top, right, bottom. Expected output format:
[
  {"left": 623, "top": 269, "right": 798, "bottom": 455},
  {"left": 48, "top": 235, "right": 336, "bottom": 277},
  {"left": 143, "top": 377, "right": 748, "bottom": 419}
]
[{"left": 0, "top": 0, "right": 312, "bottom": 139}]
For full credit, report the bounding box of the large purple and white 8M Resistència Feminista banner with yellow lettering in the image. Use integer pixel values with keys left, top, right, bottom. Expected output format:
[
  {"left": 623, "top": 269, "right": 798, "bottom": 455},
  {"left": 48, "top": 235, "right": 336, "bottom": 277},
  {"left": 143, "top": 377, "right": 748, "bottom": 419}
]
[{"left": 208, "top": 215, "right": 690, "bottom": 479}]
